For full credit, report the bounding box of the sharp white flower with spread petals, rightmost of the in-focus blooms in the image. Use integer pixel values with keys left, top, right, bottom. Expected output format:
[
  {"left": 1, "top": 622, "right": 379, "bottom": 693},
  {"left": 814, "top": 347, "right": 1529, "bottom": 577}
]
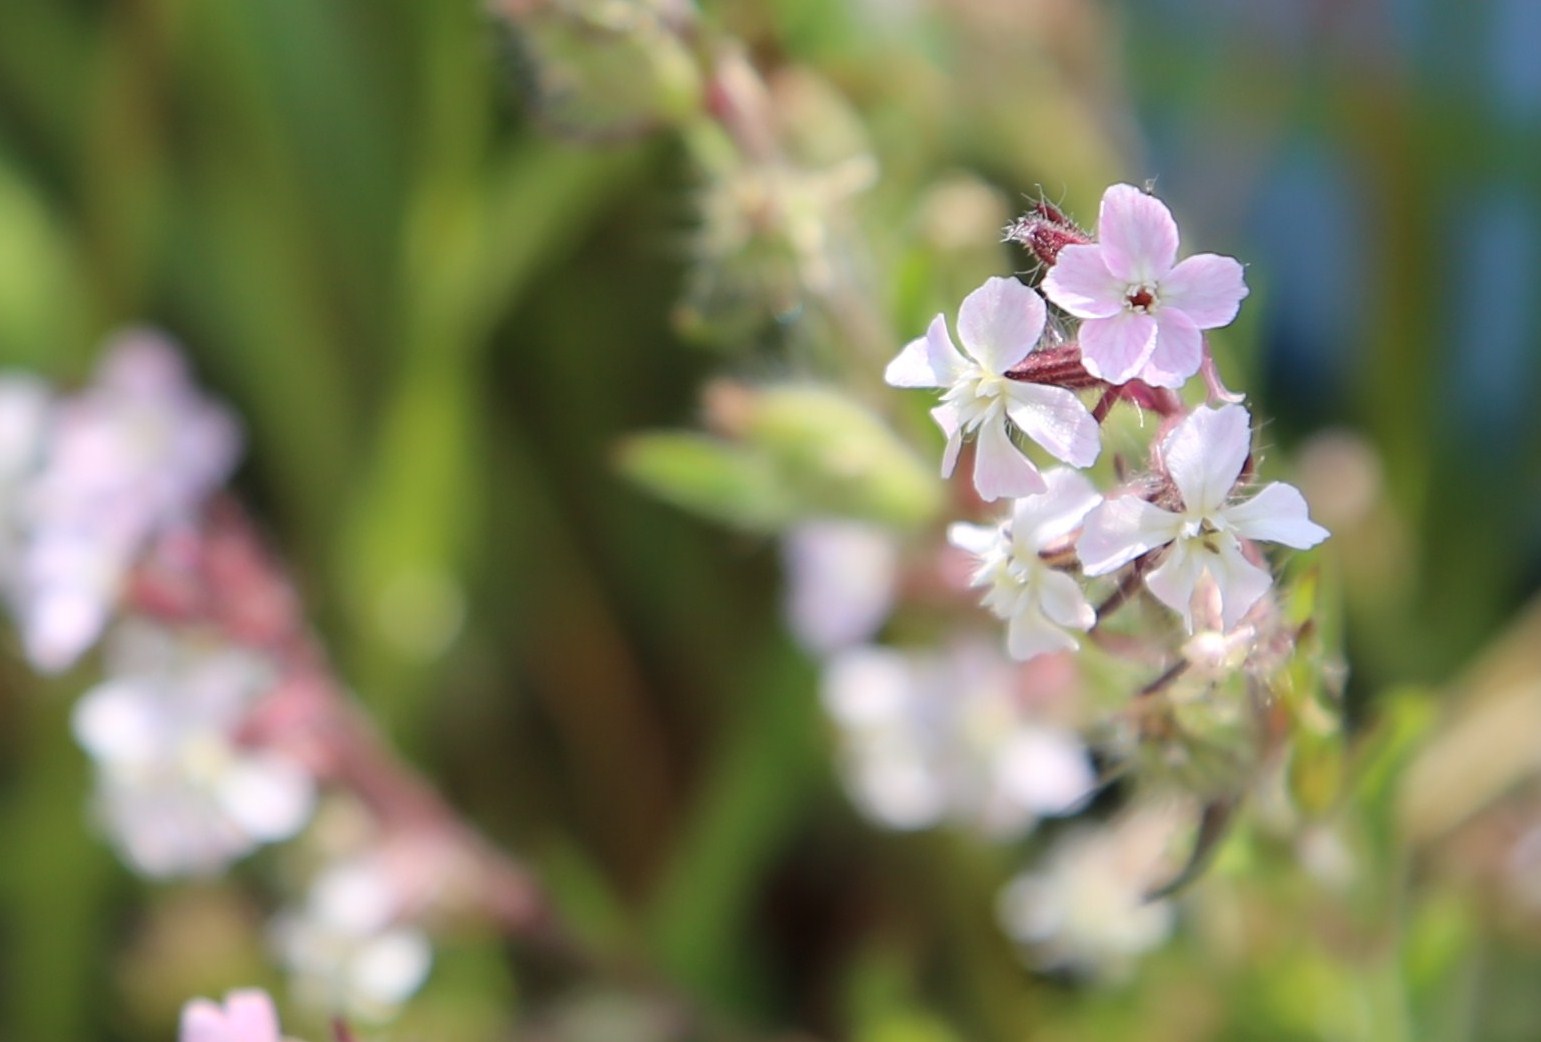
[{"left": 1076, "top": 405, "right": 1328, "bottom": 632}]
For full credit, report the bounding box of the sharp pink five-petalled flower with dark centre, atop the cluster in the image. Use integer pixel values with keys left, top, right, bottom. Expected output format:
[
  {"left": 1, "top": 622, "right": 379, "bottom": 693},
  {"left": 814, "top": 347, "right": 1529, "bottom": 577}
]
[{"left": 1043, "top": 185, "right": 1247, "bottom": 387}]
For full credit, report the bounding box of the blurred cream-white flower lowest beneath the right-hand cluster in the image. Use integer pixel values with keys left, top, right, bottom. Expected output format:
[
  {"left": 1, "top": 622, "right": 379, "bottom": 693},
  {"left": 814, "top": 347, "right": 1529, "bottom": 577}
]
[{"left": 999, "top": 806, "right": 1185, "bottom": 979}]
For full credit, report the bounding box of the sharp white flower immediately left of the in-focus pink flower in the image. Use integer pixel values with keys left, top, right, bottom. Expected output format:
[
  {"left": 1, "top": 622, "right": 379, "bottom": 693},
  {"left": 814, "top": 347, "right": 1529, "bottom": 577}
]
[{"left": 883, "top": 279, "right": 1102, "bottom": 499}]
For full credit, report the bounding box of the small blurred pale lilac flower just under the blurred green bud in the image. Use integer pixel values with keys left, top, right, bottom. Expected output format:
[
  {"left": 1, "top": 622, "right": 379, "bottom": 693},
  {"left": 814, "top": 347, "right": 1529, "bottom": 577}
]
[{"left": 781, "top": 521, "right": 898, "bottom": 655}]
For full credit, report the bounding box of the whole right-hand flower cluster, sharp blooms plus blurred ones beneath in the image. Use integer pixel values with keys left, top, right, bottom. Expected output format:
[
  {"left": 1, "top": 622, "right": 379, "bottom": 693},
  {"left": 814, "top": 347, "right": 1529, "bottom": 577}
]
[{"left": 786, "top": 185, "right": 1327, "bottom": 976}]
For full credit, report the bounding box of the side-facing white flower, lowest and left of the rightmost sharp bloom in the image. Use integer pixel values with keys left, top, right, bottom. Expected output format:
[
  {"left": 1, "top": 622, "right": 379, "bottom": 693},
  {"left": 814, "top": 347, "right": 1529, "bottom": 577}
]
[{"left": 948, "top": 467, "right": 1100, "bottom": 661}]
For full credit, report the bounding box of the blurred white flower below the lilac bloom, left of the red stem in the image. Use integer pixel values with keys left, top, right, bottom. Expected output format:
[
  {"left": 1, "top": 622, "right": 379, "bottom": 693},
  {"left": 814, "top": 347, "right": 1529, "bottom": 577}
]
[{"left": 71, "top": 623, "right": 314, "bottom": 877}]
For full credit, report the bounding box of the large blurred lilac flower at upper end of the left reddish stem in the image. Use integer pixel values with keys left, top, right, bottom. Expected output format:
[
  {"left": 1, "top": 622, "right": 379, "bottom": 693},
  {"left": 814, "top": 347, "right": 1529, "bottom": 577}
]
[{"left": 9, "top": 331, "right": 240, "bottom": 672}]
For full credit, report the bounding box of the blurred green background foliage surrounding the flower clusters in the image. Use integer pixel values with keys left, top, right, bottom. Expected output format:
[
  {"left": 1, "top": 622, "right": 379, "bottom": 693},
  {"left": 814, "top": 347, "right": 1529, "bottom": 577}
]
[{"left": 9, "top": 0, "right": 1541, "bottom": 1042}]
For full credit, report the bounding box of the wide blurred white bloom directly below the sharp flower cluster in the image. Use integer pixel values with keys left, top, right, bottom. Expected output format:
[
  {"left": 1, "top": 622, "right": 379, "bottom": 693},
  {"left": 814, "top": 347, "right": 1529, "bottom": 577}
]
[{"left": 823, "top": 646, "right": 1096, "bottom": 837}]
